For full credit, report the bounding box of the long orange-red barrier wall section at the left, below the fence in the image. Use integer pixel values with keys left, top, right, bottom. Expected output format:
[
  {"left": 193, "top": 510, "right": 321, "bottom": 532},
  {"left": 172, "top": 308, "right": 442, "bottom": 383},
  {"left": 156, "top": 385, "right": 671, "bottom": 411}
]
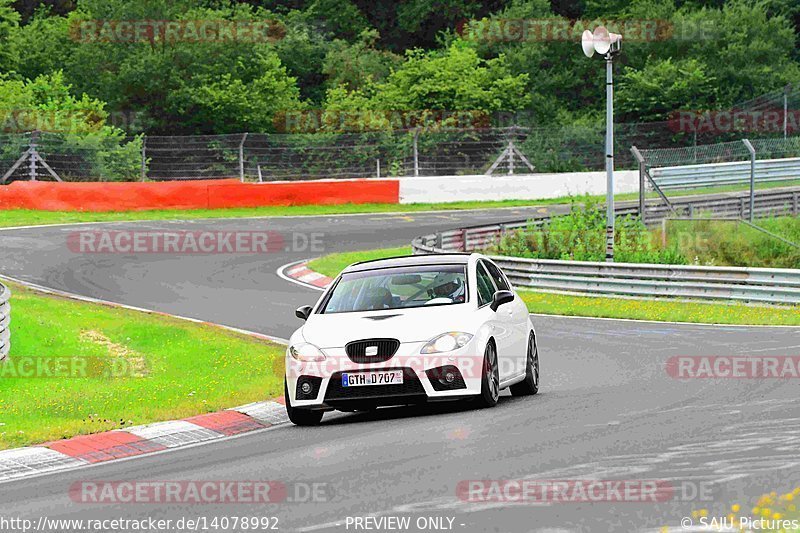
[{"left": 0, "top": 179, "right": 400, "bottom": 212}]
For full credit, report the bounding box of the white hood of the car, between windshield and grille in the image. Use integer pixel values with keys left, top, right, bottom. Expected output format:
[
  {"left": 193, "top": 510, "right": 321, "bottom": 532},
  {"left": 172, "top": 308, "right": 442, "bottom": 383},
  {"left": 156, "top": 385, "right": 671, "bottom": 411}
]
[{"left": 301, "top": 304, "right": 477, "bottom": 348}]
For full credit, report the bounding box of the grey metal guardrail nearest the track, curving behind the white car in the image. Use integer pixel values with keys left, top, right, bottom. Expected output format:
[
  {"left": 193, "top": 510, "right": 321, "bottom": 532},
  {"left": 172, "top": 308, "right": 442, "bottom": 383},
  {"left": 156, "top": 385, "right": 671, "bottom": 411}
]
[{"left": 412, "top": 191, "right": 800, "bottom": 304}]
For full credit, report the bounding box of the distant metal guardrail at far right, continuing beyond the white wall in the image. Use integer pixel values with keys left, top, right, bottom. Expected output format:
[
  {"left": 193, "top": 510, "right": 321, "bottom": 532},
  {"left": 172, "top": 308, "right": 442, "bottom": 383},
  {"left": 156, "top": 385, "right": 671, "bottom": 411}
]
[{"left": 650, "top": 157, "right": 800, "bottom": 190}]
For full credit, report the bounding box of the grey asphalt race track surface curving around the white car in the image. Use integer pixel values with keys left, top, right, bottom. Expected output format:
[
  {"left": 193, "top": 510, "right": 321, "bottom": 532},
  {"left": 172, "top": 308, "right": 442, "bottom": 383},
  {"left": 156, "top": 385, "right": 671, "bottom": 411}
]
[{"left": 0, "top": 209, "right": 800, "bottom": 532}]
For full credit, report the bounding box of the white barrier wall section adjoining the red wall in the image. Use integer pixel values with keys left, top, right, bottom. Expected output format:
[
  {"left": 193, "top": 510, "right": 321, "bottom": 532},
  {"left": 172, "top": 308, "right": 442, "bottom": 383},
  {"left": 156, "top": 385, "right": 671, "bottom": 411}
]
[{"left": 399, "top": 170, "right": 639, "bottom": 204}]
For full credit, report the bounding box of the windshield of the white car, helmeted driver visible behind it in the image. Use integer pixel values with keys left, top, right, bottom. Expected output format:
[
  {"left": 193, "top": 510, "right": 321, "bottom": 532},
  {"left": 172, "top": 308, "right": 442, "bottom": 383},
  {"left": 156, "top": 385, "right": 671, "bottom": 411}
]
[{"left": 321, "top": 265, "right": 467, "bottom": 313}]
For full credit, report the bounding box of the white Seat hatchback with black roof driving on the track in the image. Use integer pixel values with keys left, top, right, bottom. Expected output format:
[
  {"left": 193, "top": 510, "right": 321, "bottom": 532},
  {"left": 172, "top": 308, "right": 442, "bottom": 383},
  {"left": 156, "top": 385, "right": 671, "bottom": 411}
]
[{"left": 284, "top": 254, "right": 539, "bottom": 425}]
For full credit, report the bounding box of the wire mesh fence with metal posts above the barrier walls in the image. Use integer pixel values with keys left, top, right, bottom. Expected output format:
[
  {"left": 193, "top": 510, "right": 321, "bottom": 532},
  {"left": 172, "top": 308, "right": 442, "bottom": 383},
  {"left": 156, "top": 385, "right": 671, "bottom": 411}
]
[{"left": 0, "top": 113, "right": 800, "bottom": 184}]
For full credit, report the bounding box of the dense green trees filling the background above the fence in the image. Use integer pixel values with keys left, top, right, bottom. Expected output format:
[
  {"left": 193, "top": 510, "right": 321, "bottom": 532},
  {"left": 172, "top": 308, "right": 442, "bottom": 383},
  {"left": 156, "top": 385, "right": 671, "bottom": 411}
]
[{"left": 0, "top": 0, "right": 800, "bottom": 178}]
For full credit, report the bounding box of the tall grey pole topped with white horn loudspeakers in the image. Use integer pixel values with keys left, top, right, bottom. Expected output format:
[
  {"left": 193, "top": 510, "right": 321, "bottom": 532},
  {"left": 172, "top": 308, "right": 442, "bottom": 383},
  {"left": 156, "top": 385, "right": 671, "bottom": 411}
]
[{"left": 581, "top": 26, "right": 622, "bottom": 262}]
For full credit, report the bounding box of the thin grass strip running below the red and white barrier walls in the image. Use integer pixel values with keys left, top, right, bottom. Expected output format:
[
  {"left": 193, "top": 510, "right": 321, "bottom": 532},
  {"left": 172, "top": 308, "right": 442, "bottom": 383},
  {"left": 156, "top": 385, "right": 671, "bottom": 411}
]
[{"left": 0, "top": 181, "right": 800, "bottom": 227}]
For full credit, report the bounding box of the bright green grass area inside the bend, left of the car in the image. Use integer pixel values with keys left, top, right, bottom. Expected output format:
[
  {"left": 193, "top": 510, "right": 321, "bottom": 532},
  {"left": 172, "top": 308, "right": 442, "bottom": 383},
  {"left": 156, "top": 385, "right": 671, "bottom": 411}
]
[{"left": 0, "top": 284, "right": 284, "bottom": 449}]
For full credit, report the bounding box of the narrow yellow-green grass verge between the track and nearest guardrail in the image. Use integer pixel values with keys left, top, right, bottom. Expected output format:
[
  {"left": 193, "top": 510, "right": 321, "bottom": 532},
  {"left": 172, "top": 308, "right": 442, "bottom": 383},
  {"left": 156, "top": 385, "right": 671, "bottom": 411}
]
[{"left": 309, "top": 247, "right": 800, "bottom": 326}]
